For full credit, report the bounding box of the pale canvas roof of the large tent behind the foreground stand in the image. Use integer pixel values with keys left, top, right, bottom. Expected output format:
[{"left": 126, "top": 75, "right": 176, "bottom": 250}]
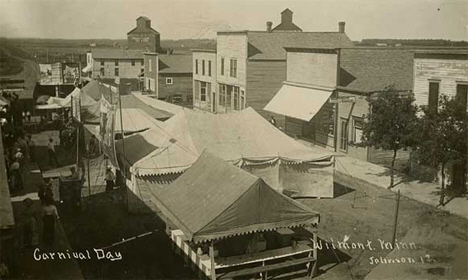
[{"left": 134, "top": 108, "right": 332, "bottom": 176}]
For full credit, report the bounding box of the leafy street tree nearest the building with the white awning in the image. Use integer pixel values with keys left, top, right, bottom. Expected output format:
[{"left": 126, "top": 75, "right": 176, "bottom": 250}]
[{"left": 360, "top": 85, "right": 418, "bottom": 188}]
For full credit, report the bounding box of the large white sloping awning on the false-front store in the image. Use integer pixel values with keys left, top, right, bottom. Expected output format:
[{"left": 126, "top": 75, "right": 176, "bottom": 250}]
[{"left": 264, "top": 83, "right": 333, "bottom": 122}]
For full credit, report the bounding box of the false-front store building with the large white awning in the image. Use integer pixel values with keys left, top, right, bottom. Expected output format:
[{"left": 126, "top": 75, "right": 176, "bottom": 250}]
[{"left": 265, "top": 48, "right": 413, "bottom": 165}]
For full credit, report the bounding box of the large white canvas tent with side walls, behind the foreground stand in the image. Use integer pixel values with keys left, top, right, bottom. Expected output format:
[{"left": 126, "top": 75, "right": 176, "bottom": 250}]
[{"left": 116, "top": 108, "right": 333, "bottom": 212}]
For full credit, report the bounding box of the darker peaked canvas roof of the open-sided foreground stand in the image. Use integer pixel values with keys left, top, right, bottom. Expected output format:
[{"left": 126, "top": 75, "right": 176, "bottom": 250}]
[{"left": 155, "top": 152, "right": 319, "bottom": 242}]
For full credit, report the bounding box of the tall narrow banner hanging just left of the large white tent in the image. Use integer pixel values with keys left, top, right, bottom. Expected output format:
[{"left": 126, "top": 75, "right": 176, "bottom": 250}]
[{"left": 99, "top": 99, "right": 119, "bottom": 168}]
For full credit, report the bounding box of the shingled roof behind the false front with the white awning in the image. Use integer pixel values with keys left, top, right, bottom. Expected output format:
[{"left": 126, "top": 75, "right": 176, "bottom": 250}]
[{"left": 339, "top": 48, "right": 413, "bottom": 92}]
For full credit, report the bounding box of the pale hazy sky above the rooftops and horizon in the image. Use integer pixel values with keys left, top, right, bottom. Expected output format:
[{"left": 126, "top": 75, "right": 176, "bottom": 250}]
[{"left": 0, "top": 0, "right": 468, "bottom": 40}]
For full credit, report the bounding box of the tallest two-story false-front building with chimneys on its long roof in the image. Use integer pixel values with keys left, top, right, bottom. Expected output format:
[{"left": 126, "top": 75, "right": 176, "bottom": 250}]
[{"left": 189, "top": 10, "right": 353, "bottom": 126}]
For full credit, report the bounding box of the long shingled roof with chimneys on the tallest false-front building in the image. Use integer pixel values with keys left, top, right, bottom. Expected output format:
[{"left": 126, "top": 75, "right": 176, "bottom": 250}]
[{"left": 246, "top": 31, "right": 354, "bottom": 61}]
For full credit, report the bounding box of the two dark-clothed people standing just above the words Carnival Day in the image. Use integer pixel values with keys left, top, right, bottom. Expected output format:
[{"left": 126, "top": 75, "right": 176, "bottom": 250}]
[{"left": 20, "top": 181, "right": 59, "bottom": 248}]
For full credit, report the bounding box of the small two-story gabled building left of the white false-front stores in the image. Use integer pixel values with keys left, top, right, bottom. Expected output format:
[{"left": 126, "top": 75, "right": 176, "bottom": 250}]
[{"left": 143, "top": 53, "right": 193, "bottom": 107}]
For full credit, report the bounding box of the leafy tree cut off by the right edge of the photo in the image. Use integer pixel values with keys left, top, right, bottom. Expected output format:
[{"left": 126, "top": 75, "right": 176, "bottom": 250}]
[{"left": 416, "top": 95, "right": 468, "bottom": 206}]
